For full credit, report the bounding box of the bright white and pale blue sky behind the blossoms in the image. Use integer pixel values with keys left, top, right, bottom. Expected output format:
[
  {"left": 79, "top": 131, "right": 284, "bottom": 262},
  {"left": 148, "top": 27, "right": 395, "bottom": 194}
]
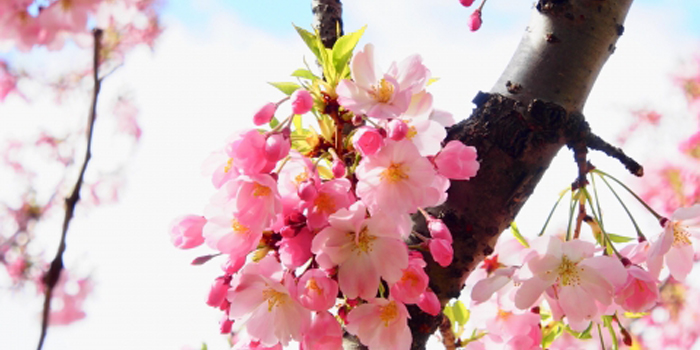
[{"left": 0, "top": 0, "right": 700, "bottom": 350}]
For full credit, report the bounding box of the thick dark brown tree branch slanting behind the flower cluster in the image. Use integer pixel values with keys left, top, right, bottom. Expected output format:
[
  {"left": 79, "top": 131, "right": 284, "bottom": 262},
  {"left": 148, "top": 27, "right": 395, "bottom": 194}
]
[{"left": 409, "top": 0, "right": 632, "bottom": 350}]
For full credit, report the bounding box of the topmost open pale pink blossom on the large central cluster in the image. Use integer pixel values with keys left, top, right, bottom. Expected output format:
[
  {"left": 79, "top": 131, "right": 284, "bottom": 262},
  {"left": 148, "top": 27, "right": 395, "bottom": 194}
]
[{"left": 336, "top": 44, "right": 416, "bottom": 119}]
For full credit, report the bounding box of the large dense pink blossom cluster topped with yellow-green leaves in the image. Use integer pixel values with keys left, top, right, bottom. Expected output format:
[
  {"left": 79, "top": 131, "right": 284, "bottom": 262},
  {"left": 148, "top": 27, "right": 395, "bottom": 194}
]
[{"left": 171, "top": 28, "right": 479, "bottom": 349}]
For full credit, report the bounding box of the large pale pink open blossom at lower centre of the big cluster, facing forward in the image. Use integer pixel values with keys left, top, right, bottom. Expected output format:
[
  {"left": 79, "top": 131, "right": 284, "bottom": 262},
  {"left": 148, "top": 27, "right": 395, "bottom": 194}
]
[{"left": 311, "top": 202, "right": 410, "bottom": 299}]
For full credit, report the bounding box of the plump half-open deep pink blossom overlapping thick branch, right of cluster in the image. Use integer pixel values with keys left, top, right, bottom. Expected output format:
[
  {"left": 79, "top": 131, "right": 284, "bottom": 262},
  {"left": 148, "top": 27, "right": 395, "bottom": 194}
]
[{"left": 434, "top": 140, "right": 479, "bottom": 180}]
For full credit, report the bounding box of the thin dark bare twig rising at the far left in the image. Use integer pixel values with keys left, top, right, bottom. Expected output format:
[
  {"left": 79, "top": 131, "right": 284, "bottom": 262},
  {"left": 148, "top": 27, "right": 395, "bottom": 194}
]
[{"left": 37, "top": 29, "right": 102, "bottom": 350}]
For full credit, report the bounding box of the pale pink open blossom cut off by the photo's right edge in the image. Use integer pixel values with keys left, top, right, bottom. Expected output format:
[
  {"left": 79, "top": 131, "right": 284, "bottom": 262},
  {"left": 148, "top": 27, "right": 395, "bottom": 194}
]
[{"left": 647, "top": 204, "right": 700, "bottom": 282}]
